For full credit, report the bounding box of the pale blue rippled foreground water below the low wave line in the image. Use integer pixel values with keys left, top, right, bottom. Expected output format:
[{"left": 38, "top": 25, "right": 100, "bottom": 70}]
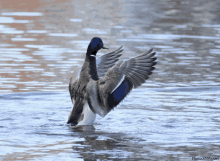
[{"left": 0, "top": 87, "right": 220, "bottom": 160}]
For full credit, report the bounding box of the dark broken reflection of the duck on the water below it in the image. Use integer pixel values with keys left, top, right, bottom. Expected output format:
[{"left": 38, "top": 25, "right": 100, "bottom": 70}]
[{"left": 70, "top": 126, "right": 130, "bottom": 160}]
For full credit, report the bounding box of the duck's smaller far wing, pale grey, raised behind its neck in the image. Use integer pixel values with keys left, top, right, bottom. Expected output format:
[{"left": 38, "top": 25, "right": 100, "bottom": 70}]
[{"left": 96, "top": 46, "right": 123, "bottom": 79}]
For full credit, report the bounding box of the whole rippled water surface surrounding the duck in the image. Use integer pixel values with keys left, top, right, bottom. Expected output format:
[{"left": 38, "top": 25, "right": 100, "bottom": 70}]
[{"left": 0, "top": 0, "right": 220, "bottom": 160}]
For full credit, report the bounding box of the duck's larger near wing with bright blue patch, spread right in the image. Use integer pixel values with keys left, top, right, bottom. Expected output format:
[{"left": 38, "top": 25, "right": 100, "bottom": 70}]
[{"left": 88, "top": 49, "right": 157, "bottom": 117}]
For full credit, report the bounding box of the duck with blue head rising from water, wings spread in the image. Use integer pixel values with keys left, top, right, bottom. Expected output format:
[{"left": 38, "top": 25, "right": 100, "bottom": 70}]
[{"left": 67, "top": 37, "right": 157, "bottom": 126}]
